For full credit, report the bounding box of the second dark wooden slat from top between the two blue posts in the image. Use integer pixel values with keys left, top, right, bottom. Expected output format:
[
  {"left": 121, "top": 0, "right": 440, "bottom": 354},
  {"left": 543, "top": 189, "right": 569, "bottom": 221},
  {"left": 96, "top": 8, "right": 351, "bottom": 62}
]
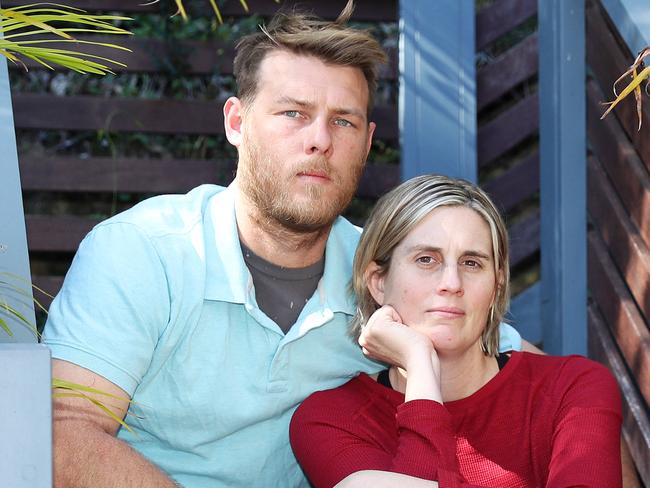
[{"left": 476, "top": 33, "right": 538, "bottom": 110}]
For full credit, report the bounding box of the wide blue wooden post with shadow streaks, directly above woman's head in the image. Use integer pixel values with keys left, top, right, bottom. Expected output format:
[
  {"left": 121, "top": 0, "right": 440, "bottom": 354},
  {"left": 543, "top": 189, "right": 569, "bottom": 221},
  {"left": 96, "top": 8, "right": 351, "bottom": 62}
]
[{"left": 399, "top": 0, "right": 477, "bottom": 181}]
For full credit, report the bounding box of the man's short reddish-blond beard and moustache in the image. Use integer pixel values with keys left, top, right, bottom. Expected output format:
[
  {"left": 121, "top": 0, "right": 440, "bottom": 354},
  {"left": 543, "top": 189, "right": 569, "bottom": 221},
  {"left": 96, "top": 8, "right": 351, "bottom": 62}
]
[{"left": 237, "top": 136, "right": 364, "bottom": 233}]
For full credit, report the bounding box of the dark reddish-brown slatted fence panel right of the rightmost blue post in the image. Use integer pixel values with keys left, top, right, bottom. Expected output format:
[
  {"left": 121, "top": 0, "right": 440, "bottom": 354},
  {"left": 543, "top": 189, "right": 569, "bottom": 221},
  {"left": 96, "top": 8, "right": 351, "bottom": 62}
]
[{"left": 586, "top": 1, "right": 650, "bottom": 486}]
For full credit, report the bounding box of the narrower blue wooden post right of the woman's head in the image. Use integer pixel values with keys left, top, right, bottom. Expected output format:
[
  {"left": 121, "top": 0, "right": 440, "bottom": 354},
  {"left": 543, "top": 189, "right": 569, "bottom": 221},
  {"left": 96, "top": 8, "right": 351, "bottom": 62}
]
[{"left": 538, "top": 0, "right": 587, "bottom": 354}]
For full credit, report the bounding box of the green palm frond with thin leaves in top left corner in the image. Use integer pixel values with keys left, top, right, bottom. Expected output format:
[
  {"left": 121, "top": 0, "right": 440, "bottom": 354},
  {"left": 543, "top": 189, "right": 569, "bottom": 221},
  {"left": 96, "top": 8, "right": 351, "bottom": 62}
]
[{"left": 0, "top": 3, "right": 131, "bottom": 75}]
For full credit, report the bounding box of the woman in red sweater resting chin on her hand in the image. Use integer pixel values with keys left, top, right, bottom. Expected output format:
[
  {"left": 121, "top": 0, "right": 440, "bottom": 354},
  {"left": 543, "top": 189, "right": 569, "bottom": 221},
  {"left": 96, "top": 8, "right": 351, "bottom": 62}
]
[{"left": 291, "top": 176, "right": 621, "bottom": 487}]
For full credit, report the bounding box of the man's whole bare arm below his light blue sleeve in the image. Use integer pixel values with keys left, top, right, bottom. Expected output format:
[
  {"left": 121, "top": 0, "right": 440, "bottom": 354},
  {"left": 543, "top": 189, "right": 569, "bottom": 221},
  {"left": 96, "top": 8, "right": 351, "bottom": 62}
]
[{"left": 52, "top": 359, "right": 177, "bottom": 488}]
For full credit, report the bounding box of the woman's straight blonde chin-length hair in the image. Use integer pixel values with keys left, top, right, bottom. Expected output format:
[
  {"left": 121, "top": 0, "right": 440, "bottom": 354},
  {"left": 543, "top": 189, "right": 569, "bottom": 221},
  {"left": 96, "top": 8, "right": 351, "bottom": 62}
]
[{"left": 350, "top": 175, "right": 510, "bottom": 356}]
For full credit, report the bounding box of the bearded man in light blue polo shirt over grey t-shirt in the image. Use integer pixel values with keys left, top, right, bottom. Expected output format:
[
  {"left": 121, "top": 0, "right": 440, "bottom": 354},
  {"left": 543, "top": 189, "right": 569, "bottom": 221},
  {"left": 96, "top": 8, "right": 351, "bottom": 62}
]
[{"left": 44, "top": 1, "right": 518, "bottom": 488}]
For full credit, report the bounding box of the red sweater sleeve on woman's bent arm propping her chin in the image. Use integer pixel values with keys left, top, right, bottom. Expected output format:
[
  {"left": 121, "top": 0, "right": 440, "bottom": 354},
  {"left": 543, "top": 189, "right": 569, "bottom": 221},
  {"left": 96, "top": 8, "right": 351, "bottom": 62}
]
[{"left": 290, "top": 390, "right": 480, "bottom": 488}]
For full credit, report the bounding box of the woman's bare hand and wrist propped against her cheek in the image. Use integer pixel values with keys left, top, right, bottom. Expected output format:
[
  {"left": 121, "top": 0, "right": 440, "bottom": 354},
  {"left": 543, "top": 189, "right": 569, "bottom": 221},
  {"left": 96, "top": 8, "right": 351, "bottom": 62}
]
[{"left": 359, "top": 305, "right": 442, "bottom": 403}]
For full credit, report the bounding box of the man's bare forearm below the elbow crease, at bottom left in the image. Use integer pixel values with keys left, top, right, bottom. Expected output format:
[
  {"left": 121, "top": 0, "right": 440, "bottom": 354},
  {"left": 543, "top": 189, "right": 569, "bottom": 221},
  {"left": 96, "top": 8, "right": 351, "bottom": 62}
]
[{"left": 53, "top": 421, "right": 178, "bottom": 488}]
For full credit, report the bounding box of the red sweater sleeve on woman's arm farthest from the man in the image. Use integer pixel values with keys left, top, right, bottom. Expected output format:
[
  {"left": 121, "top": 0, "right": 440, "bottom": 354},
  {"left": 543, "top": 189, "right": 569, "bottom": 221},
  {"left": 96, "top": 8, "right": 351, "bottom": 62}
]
[{"left": 546, "top": 357, "right": 622, "bottom": 488}]
